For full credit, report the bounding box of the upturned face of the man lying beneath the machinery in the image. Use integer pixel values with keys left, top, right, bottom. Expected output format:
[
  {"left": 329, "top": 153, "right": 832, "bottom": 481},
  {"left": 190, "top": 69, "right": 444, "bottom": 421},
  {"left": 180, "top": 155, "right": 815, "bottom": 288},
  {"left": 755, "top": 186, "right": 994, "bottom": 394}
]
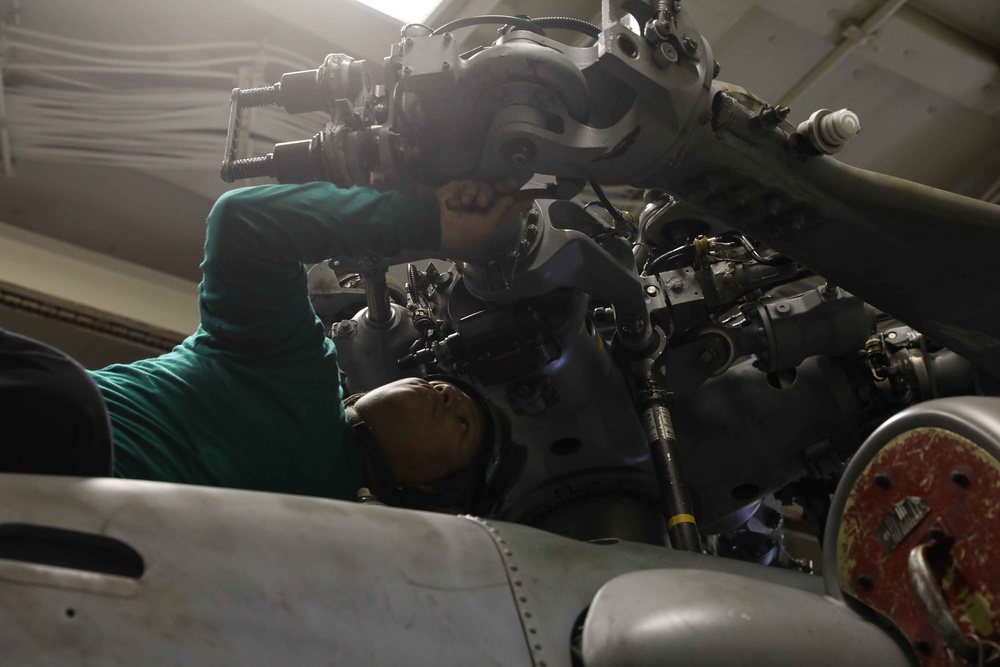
[{"left": 354, "top": 378, "right": 485, "bottom": 488}]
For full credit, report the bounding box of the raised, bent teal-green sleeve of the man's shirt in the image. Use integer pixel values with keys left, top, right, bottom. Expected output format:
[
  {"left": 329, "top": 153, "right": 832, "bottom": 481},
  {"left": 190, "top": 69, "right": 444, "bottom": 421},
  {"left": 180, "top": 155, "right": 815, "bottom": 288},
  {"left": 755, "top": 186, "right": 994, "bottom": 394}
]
[{"left": 193, "top": 183, "right": 441, "bottom": 361}]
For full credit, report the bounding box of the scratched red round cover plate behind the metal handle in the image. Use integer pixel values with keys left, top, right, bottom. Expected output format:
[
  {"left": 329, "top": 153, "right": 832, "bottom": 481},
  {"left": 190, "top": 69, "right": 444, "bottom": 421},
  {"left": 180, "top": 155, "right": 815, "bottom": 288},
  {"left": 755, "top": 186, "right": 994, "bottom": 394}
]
[{"left": 837, "top": 428, "right": 1000, "bottom": 667}]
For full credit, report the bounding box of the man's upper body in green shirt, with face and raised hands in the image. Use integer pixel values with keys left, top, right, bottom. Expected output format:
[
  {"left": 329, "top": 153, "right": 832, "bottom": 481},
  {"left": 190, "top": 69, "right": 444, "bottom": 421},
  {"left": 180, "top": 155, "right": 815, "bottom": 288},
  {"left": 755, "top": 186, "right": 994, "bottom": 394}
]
[{"left": 93, "top": 181, "right": 525, "bottom": 506}]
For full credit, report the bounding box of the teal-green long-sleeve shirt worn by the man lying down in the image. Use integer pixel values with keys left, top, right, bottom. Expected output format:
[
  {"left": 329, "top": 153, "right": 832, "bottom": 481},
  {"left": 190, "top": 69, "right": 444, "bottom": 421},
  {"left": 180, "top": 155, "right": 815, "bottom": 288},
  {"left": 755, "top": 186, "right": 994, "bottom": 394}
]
[{"left": 93, "top": 183, "right": 440, "bottom": 499}]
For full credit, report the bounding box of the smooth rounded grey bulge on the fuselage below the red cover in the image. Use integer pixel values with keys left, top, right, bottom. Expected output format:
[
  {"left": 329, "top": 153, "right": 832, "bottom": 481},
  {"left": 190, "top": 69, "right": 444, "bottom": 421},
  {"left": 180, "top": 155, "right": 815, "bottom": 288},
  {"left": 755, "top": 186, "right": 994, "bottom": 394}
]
[{"left": 582, "top": 569, "right": 913, "bottom": 667}]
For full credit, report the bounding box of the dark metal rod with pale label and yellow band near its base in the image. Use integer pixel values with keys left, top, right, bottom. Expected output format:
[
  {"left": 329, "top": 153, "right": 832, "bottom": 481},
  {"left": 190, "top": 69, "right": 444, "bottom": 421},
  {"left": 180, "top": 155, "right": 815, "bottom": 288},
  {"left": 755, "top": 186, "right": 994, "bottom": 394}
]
[{"left": 639, "top": 380, "right": 702, "bottom": 553}]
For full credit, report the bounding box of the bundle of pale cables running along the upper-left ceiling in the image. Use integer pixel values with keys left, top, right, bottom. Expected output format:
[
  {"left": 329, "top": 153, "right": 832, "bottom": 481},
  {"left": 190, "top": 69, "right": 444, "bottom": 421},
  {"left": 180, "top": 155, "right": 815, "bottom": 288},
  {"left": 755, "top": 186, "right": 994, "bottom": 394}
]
[{"left": 0, "top": 25, "right": 326, "bottom": 169}]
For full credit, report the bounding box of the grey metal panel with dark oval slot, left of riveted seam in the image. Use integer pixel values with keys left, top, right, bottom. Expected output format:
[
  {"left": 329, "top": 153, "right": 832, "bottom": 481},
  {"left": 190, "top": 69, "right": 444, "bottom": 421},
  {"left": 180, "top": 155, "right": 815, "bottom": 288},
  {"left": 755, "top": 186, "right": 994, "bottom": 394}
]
[{"left": 0, "top": 475, "right": 530, "bottom": 667}]
